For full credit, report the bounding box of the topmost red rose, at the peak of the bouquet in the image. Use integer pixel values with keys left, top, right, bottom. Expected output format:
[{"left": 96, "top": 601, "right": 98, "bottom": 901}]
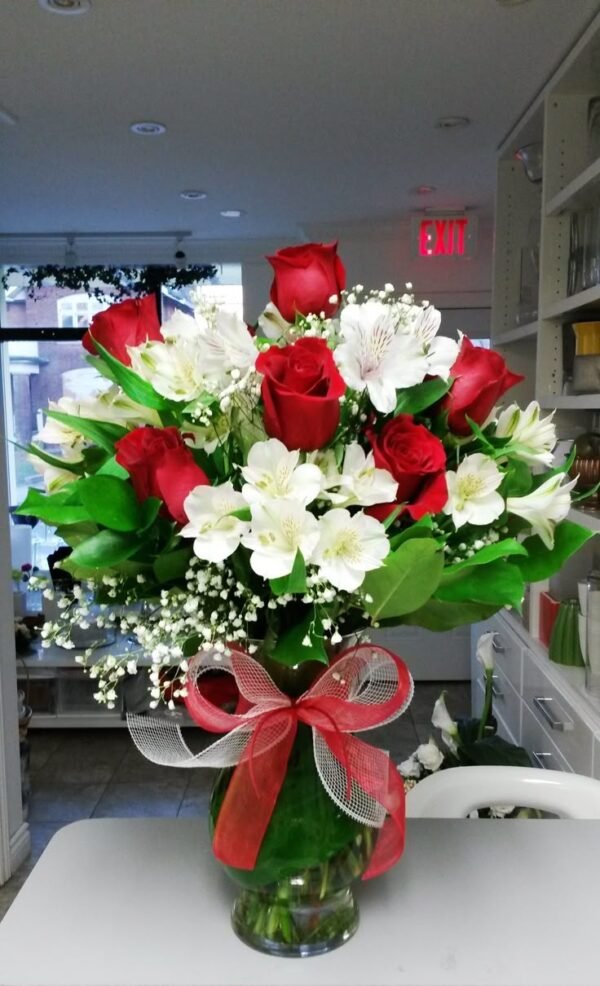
[{"left": 267, "top": 243, "right": 346, "bottom": 322}]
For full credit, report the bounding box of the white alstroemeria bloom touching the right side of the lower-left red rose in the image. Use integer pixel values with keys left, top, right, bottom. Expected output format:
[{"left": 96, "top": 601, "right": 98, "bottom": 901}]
[{"left": 181, "top": 482, "right": 250, "bottom": 562}]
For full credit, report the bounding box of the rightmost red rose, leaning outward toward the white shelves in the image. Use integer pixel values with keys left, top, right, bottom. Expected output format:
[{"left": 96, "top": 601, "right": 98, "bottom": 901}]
[{"left": 441, "top": 336, "right": 525, "bottom": 435}]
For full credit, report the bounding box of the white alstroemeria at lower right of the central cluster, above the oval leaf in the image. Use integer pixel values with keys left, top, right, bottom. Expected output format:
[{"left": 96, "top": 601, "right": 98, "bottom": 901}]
[{"left": 312, "top": 508, "right": 390, "bottom": 592}]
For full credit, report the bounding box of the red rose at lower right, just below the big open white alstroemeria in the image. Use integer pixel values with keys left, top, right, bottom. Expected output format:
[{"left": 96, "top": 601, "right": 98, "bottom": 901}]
[{"left": 367, "top": 414, "right": 448, "bottom": 520}]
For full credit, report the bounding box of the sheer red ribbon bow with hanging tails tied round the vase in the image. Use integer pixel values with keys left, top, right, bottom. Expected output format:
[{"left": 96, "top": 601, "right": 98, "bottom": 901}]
[{"left": 185, "top": 645, "right": 412, "bottom": 879}]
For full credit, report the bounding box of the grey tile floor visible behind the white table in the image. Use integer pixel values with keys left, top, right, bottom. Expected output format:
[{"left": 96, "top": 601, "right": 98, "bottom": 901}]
[{"left": 0, "top": 682, "right": 470, "bottom": 920}]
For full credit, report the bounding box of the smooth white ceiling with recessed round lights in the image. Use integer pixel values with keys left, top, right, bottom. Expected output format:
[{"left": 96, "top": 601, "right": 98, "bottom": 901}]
[{"left": 0, "top": 0, "right": 600, "bottom": 241}]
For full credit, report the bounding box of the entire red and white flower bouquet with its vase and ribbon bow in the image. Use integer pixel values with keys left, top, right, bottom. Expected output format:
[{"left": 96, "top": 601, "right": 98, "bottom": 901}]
[{"left": 20, "top": 244, "right": 590, "bottom": 955}]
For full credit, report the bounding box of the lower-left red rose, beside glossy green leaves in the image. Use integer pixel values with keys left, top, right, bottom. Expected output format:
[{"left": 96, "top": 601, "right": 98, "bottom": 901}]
[{"left": 115, "top": 425, "right": 209, "bottom": 524}]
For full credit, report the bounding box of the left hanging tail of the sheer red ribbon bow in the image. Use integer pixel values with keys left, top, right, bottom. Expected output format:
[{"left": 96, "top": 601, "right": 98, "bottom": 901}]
[{"left": 213, "top": 713, "right": 297, "bottom": 870}]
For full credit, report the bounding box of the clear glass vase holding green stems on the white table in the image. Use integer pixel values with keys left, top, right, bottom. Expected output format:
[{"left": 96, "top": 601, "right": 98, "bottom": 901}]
[{"left": 210, "top": 662, "right": 378, "bottom": 956}]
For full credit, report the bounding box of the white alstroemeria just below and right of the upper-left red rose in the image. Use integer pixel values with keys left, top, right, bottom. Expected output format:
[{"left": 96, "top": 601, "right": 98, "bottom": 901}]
[{"left": 127, "top": 337, "right": 206, "bottom": 401}]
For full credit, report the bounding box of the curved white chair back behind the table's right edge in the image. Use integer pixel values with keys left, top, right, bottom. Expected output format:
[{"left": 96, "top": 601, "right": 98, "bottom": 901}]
[{"left": 406, "top": 766, "right": 600, "bottom": 818}]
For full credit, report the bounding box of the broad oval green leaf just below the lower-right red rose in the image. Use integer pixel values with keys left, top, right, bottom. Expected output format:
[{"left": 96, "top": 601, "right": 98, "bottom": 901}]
[{"left": 361, "top": 538, "right": 444, "bottom": 620}]
